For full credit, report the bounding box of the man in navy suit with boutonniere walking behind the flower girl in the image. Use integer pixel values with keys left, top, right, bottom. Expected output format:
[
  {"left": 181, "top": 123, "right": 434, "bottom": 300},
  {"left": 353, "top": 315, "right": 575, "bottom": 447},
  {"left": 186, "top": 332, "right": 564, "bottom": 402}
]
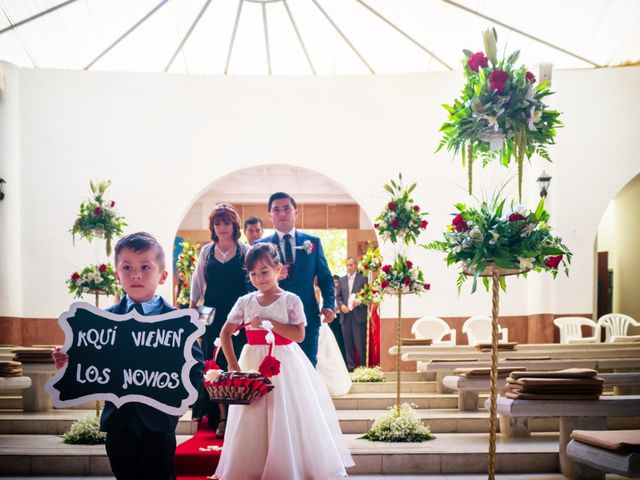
[{"left": 258, "top": 192, "right": 335, "bottom": 367}]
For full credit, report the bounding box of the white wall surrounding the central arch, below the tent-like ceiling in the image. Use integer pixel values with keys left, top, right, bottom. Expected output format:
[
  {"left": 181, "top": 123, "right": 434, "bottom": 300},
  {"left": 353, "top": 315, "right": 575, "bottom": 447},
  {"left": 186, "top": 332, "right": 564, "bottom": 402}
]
[{"left": 0, "top": 64, "right": 640, "bottom": 317}]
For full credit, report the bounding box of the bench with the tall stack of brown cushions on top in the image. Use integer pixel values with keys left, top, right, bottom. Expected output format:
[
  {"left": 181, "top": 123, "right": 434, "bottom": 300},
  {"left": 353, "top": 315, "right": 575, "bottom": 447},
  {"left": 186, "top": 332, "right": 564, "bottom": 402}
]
[{"left": 485, "top": 395, "right": 640, "bottom": 479}]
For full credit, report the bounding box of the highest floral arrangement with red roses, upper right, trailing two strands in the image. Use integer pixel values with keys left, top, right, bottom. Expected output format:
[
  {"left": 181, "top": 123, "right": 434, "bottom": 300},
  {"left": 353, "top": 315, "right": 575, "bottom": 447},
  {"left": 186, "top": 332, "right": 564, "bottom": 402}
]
[{"left": 438, "top": 29, "right": 561, "bottom": 199}]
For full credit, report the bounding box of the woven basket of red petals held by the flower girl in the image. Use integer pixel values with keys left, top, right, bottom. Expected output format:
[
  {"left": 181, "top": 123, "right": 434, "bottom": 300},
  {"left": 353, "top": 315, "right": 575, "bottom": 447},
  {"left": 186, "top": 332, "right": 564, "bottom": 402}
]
[{"left": 204, "top": 372, "right": 274, "bottom": 405}]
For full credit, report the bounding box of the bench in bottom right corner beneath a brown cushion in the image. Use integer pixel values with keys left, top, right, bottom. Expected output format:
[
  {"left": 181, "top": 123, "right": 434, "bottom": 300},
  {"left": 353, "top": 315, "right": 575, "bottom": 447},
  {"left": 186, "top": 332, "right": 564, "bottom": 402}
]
[{"left": 567, "top": 440, "right": 640, "bottom": 480}]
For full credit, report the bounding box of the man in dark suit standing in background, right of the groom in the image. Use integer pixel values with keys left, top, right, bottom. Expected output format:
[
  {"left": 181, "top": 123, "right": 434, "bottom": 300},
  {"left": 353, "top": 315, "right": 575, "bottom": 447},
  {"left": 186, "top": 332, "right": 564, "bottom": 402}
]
[{"left": 336, "top": 257, "right": 367, "bottom": 372}]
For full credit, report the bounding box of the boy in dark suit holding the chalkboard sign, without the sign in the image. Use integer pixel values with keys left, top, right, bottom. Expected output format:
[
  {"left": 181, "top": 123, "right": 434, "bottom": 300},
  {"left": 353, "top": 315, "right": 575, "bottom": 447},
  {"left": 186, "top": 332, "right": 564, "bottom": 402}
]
[{"left": 53, "top": 232, "right": 204, "bottom": 480}]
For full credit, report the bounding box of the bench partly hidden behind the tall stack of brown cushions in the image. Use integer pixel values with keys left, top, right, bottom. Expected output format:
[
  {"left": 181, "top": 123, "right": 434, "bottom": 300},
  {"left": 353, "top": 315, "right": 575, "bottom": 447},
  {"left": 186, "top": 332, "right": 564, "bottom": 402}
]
[{"left": 442, "top": 372, "right": 640, "bottom": 414}]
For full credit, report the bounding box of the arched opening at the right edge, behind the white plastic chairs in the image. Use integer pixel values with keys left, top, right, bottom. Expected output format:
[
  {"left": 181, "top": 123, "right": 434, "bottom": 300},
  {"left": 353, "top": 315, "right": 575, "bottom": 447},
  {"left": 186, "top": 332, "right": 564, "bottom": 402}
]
[{"left": 596, "top": 174, "right": 640, "bottom": 334}]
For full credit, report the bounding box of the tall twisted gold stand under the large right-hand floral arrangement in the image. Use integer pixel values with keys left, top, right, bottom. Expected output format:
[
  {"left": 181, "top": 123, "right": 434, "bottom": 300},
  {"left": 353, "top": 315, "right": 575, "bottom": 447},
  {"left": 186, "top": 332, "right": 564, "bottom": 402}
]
[{"left": 468, "top": 264, "right": 528, "bottom": 480}]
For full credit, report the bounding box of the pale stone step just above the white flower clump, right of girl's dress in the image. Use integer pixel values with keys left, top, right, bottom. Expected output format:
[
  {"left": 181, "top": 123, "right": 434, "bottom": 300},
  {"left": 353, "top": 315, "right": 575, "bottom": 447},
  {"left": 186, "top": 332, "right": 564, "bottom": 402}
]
[{"left": 333, "top": 393, "right": 458, "bottom": 410}]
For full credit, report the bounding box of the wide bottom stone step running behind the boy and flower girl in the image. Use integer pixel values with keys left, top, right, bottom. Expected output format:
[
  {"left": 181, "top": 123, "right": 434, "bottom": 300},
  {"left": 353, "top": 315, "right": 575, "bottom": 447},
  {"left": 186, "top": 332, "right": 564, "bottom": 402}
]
[{"left": 0, "top": 433, "right": 559, "bottom": 476}]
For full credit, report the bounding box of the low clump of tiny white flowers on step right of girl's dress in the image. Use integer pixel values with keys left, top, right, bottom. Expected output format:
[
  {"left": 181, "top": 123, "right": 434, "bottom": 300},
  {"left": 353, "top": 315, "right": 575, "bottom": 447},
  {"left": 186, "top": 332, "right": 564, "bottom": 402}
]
[{"left": 360, "top": 403, "right": 436, "bottom": 442}]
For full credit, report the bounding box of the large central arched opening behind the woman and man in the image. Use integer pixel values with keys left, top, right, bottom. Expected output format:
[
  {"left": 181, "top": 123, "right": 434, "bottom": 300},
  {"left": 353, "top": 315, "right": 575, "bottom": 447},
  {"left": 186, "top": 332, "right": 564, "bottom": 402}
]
[{"left": 173, "top": 165, "right": 380, "bottom": 364}]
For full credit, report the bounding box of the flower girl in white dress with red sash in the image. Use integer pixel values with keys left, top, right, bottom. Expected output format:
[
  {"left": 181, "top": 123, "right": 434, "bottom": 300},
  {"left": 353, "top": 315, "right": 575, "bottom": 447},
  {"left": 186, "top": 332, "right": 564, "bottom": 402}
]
[{"left": 214, "top": 243, "right": 354, "bottom": 480}]
